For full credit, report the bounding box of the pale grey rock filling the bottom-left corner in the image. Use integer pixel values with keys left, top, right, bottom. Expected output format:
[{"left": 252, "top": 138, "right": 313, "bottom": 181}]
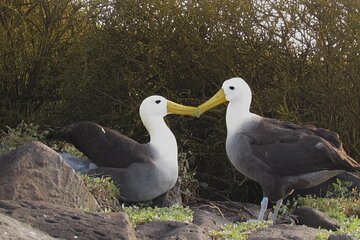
[{"left": 0, "top": 214, "right": 55, "bottom": 240}]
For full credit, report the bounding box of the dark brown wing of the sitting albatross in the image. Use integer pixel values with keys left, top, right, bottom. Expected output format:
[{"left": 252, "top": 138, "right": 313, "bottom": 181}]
[{"left": 55, "top": 122, "right": 152, "bottom": 168}]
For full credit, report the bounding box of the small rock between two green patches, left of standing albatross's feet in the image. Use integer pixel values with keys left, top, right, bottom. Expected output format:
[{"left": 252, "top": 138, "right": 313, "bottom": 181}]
[{"left": 192, "top": 208, "right": 231, "bottom": 232}]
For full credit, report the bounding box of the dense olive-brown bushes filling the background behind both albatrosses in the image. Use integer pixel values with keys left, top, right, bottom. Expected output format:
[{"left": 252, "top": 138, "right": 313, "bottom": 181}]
[{"left": 0, "top": 0, "right": 360, "bottom": 201}]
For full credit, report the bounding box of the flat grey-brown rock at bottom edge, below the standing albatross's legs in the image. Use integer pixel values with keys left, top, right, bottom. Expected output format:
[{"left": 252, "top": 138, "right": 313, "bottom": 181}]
[{"left": 248, "top": 224, "right": 319, "bottom": 240}]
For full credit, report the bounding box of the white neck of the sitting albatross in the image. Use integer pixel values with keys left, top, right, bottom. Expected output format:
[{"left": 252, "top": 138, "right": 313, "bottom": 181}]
[{"left": 142, "top": 116, "right": 178, "bottom": 166}]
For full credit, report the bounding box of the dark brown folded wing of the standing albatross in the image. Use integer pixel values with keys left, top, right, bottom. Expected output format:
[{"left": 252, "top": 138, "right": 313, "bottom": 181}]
[{"left": 244, "top": 118, "right": 359, "bottom": 175}]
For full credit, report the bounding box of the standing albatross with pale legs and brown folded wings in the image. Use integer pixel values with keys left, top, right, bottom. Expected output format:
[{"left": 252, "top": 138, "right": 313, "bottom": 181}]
[{"left": 197, "top": 78, "right": 360, "bottom": 221}]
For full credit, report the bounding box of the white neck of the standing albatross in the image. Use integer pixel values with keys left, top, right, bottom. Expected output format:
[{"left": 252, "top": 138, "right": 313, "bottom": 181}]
[{"left": 226, "top": 100, "right": 258, "bottom": 136}]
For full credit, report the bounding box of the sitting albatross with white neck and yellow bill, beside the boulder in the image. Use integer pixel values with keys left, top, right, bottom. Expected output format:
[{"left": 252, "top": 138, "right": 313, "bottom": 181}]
[{"left": 55, "top": 95, "right": 196, "bottom": 202}]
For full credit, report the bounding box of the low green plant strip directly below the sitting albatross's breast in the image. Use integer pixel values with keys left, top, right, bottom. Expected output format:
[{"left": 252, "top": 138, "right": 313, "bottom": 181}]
[{"left": 124, "top": 205, "right": 193, "bottom": 227}]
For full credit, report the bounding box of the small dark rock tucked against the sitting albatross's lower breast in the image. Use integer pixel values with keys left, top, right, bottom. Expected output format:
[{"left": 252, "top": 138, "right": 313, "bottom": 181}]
[{"left": 152, "top": 179, "right": 182, "bottom": 207}]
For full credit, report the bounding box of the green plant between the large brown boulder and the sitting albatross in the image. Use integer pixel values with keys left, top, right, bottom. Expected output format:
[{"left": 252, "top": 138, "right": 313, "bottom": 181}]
[{"left": 80, "top": 174, "right": 121, "bottom": 212}]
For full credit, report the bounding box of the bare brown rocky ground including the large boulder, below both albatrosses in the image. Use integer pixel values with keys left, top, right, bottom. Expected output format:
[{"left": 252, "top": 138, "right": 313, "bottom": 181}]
[{"left": 0, "top": 142, "right": 359, "bottom": 240}]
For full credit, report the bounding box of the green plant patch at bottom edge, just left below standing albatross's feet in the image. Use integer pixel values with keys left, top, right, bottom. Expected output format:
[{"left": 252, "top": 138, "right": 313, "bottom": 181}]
[{"left": 210, "top": 221, "right": 272, "bottom": 240}]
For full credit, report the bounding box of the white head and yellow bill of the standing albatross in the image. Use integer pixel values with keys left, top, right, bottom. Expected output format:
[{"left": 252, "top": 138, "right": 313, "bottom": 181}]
[{"left": 196, "top": 77, "right": 252, "bottom": 117}]
